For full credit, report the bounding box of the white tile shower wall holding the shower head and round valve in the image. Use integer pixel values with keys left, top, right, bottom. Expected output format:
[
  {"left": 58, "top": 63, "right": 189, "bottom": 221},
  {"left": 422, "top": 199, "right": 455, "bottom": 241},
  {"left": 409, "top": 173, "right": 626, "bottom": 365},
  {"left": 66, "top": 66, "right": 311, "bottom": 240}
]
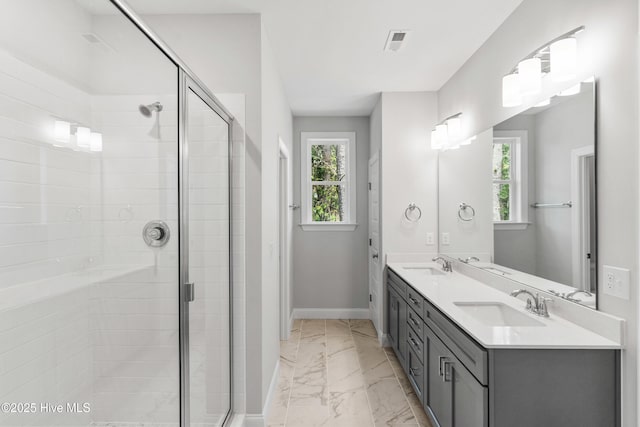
[{"left": 91, "top": 95, "right": 179, "bottom": 423}]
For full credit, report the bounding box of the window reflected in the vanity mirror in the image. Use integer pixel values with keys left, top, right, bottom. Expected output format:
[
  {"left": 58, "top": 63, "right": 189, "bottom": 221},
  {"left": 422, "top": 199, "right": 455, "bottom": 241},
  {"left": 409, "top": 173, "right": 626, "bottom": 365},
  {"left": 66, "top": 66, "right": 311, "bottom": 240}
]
[{"left": 492, "top": 131, "right": 529, "bottom": 229}]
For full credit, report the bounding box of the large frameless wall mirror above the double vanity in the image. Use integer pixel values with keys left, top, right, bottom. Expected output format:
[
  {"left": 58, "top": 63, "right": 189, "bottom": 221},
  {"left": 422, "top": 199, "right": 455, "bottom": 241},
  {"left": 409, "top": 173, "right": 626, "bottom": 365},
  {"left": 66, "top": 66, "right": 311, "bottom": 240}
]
[{"left": 439, "top": 79, "right": 598, "bottom": 308}]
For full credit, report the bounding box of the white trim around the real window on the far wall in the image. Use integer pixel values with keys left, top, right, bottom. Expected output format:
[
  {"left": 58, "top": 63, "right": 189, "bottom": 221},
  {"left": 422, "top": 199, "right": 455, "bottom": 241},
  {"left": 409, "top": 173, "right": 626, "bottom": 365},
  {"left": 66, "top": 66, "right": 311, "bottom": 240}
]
[{"left": 300, "top": 132, "right": 358, "bottom": 231}]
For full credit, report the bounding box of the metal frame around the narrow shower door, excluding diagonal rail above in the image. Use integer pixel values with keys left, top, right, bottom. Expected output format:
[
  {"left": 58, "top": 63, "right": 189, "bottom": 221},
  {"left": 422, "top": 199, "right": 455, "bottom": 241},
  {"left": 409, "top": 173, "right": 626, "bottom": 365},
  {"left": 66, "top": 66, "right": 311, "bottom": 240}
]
[{"left": 178, "top": 68, "right": 234, "bottom": 427}]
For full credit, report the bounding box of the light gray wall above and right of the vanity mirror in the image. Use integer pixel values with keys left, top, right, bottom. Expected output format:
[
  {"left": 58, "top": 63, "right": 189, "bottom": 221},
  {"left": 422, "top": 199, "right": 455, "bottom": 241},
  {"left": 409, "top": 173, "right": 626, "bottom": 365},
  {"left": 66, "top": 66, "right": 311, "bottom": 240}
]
[{"left": 438, "top": 0, "right": 638, "bottom": 427}]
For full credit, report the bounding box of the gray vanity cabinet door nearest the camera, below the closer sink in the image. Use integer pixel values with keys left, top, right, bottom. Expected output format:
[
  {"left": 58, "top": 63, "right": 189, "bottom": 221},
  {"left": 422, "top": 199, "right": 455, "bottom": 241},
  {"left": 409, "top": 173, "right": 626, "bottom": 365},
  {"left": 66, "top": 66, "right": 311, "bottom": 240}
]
[{"left": 450, "top": 360, "right": 489, "bottom": 427}]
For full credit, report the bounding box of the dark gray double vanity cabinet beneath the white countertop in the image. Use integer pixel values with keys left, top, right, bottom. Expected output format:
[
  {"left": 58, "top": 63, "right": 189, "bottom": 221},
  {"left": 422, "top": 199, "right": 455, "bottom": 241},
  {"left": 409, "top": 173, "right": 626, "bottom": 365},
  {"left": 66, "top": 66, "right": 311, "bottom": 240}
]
[{"left": 387, "top": 269, "right": 620, "bottom": 427}]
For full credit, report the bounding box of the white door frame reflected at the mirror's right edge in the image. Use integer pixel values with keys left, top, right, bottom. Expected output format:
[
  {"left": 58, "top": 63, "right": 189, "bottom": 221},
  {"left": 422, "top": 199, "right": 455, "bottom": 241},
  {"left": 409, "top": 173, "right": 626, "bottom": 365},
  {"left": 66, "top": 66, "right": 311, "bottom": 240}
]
[{"left": 571, "top": 145, "right": 597, "bottom": 292}]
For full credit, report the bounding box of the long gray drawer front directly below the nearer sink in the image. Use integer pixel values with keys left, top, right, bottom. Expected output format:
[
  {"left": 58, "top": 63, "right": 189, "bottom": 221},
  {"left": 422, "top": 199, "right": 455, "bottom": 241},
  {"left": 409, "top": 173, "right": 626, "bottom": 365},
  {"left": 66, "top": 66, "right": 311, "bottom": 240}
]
[{"left": 423, "top": 302, "right": 488, "bottom": 385}]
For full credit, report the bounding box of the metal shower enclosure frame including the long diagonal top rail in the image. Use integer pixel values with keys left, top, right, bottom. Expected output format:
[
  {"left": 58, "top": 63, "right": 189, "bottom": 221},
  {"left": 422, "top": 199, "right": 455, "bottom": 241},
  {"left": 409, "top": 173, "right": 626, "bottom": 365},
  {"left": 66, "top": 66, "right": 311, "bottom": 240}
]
[{"left": 109, "top": 0, "right": 234, "bottom": 427}]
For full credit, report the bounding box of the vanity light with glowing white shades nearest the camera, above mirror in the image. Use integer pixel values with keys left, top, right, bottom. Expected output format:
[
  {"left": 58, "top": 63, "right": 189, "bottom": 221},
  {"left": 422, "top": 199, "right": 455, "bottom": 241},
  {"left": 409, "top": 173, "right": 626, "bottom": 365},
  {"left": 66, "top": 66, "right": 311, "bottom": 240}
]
[{"left": 502, "top": 26, "right": 584, "bottom": 108}]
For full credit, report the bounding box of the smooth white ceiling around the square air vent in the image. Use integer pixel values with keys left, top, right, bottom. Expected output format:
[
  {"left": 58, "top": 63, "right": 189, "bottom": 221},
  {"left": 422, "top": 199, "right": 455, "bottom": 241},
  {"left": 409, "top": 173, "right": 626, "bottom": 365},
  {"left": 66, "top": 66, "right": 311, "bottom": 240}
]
[{"left": 80, "top": 0, "right": 522, "bottom": 115}]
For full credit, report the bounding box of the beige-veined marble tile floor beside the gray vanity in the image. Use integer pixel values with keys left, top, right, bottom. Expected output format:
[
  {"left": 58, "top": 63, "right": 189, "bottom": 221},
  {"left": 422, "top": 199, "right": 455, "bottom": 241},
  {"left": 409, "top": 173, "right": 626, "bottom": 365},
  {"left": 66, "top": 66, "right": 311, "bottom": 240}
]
[{"left": 267, "top": 319, "right": 432, "bottom": 427}]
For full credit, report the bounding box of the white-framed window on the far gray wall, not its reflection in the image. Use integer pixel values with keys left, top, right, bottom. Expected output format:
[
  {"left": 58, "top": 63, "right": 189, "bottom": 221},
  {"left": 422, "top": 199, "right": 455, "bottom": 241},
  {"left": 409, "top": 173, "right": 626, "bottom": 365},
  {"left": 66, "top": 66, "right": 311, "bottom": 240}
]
[{"left": 300, "top": 132, "right": 356, "bottom": 231}]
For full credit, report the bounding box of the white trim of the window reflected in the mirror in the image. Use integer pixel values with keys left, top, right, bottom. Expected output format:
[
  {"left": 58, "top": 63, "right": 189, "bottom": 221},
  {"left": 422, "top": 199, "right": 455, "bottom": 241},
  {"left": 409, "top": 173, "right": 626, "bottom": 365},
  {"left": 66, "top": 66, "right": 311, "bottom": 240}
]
[{"left": 493, "top": 130, "right": 531, "bottom": 230}]
